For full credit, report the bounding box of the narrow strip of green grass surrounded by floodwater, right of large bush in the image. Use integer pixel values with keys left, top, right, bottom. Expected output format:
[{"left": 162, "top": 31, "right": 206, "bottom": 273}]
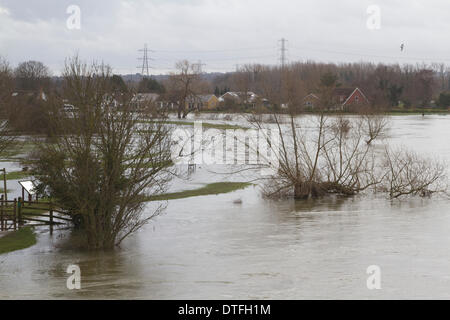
[{"left": 148, "top": 182, "right": 251, "bottom": 201}]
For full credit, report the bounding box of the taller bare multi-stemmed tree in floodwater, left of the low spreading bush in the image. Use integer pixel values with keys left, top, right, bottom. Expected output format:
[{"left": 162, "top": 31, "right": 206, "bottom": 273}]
[{"left": 251, "top": 68, "right": 377, "bottom": 199}]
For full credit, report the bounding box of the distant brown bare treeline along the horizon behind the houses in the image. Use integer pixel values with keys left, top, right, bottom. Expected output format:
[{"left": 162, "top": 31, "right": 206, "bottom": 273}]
[{"left": 0, "top": 58, "right": 450, "bottom": 132}]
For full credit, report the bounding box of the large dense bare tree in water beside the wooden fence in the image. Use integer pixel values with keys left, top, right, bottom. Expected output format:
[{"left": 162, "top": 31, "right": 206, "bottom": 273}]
[{"left": 33, "top": 58, "right": 170, "bottom": 249}]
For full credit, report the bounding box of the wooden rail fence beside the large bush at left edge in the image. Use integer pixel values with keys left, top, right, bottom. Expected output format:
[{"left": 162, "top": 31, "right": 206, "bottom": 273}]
[{"left": 0, "top": 195, "right": 72, "bottom": 234}]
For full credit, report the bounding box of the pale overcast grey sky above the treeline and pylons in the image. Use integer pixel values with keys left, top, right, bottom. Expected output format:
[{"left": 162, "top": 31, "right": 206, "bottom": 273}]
[{"left": 0, "top": 0, "right": 450, "bottom": 74}]
